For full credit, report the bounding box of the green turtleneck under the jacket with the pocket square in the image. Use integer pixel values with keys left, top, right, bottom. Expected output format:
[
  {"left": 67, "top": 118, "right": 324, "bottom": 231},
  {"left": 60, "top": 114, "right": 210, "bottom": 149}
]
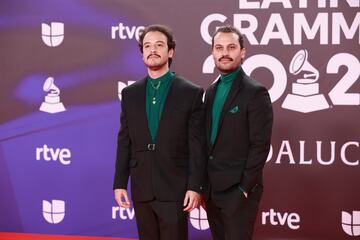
[{"left": 210, "top": 67, "right": 240, "bottom": 145}]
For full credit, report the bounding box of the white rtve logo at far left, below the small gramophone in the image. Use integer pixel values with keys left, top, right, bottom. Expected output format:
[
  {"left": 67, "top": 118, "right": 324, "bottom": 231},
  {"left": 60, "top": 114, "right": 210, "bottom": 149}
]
[{"left": 36, "top": 144, "right": 71, "bottom": 165}]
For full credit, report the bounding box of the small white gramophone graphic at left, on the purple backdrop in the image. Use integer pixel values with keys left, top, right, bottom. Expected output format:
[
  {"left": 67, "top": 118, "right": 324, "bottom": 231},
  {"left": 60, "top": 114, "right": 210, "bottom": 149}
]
[{"left": 40, "top": 77, "right": 66, "bottom": 113}]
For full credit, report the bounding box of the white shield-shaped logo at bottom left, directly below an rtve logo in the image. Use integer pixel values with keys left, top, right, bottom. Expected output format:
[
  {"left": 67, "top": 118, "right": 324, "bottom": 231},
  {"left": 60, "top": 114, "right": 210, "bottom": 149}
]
[{"left": 42, "top": 200, "right": 65, "bottom": 224}]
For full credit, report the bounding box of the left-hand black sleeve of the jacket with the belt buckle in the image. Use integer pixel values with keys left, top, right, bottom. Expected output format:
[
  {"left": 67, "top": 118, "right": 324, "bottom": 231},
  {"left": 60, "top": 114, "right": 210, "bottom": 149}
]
[{"left": 113, "top": 89, "right": 131, "bottom": 189}]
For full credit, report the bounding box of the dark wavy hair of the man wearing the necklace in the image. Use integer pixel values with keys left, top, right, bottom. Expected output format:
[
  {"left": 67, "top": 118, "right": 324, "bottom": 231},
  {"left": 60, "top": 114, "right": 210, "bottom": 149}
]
[{"left": 138, "top": 24, "right": 176, "bottom": 66}]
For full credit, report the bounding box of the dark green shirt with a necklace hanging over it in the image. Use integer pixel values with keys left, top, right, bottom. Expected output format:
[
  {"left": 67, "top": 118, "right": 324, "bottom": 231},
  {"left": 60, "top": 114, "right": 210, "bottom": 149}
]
[{"left": 146, "top": 71, "right": 174, "bottom": 142}]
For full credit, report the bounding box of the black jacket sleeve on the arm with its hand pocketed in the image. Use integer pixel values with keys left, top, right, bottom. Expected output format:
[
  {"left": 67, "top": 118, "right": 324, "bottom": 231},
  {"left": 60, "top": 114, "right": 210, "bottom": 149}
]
[{"left": 240, "top": 87, "right": 273, "bottom": 192}]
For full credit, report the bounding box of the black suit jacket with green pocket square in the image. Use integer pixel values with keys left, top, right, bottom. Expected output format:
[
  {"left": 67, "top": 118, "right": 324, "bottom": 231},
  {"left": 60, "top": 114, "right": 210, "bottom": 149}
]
[{"left": 205, "top": 69, "right": 273, "bottom": 196}]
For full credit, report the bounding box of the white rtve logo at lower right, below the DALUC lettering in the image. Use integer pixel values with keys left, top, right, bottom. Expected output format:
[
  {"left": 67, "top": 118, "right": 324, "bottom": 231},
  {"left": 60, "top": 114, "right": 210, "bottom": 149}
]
[{"left": 261, "top": 208, "right": 300, "bottom": 230}]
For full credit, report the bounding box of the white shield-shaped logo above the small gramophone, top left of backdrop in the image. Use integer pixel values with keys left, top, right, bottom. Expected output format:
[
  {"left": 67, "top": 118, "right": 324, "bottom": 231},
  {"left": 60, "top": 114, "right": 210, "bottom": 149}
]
[{"left": 41, "top": 22, "right": 64, "bottom": 47}]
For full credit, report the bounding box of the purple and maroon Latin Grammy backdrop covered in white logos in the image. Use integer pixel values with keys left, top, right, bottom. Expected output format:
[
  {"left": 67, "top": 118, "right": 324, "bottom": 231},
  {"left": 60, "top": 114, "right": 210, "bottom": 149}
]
[{"left": 0, "top": 0, "right": 360, "bottom": 239}]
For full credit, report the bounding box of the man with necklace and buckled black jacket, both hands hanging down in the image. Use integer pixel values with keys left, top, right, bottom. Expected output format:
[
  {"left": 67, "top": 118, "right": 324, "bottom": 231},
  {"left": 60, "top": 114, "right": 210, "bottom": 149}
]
[{"left": 113, "top": 25, "right": 206, "bottom": 240}]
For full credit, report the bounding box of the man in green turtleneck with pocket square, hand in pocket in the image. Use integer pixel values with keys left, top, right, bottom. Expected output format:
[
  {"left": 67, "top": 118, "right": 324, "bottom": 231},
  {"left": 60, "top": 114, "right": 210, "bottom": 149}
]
[{"left": 205, "top": 26, "right": 273, "bottom": 240}]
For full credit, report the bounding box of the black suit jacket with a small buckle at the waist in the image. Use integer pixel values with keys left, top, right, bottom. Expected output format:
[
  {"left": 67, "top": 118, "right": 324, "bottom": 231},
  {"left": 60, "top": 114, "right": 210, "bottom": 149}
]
[{"left": 114, "top": 75, "right": 206, "bottom": 201}]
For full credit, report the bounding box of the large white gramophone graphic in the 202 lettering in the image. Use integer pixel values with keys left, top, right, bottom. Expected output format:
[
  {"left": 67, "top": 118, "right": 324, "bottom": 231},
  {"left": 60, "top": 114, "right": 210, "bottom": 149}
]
[{"left": 281, "top": 49, "right": 329, "bottom": 113}]
